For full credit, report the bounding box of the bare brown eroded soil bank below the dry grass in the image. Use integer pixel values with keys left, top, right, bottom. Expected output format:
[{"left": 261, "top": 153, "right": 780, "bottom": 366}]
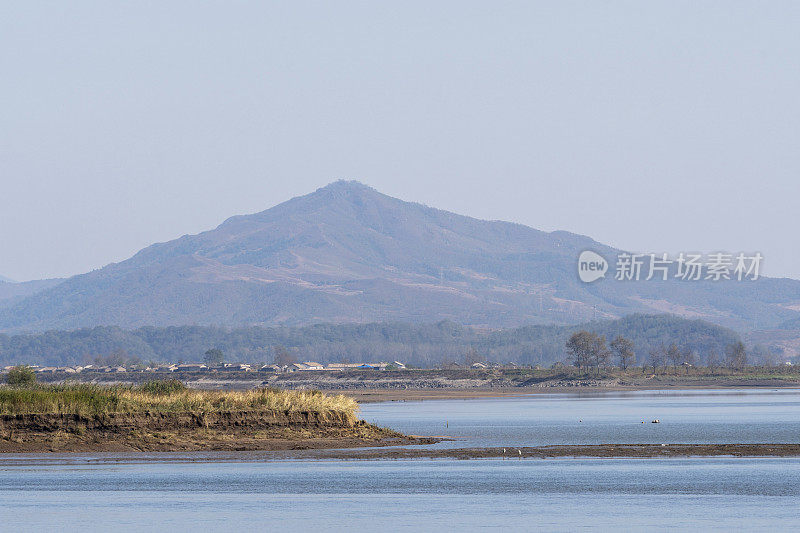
[{"left": 0, "top": 411, "right": 436, "bottom": 453}]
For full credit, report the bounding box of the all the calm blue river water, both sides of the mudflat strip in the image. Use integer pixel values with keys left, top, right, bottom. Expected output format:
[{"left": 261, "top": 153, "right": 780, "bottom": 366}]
[{"left": 0, "top": 391, "right": 800, "bottom": 532}]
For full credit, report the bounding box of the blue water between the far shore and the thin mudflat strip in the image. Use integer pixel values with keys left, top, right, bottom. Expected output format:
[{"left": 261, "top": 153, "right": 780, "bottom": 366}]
[{"left": 361, "top": 389, "right": 800, "bottom": 447}]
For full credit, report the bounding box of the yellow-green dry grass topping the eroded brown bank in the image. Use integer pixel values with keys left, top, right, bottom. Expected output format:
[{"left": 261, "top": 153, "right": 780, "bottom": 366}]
[{"left": 0, "top": 384, "right": 358, "bottom": 419}]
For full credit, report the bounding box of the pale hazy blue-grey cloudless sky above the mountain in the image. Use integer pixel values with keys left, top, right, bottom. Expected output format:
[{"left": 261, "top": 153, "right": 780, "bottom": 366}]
[{"left": 0, "top": 0, "right": 800, "bottom": 280}]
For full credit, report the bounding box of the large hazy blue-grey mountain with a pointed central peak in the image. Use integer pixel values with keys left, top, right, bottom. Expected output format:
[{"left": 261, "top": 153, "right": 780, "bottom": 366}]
[{"left": 0, "top": 181, "right": 800, "bottom": 332}]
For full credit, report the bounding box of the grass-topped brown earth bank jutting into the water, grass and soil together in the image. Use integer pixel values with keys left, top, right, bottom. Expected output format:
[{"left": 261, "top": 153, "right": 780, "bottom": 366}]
[{"left": 0, "top": 380, "right": 436, "bottom": 453}]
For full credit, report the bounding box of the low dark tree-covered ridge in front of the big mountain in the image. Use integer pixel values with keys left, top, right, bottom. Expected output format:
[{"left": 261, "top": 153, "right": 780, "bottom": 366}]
[{"left": 0, "top": 315, "right": 739, "bottom": 367}]
